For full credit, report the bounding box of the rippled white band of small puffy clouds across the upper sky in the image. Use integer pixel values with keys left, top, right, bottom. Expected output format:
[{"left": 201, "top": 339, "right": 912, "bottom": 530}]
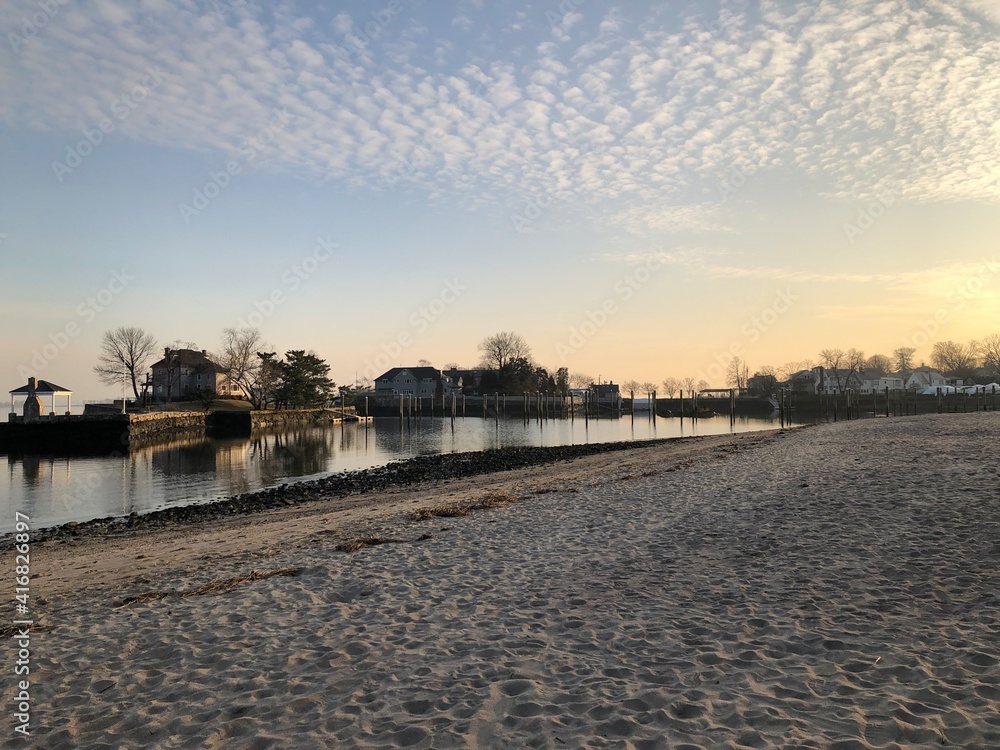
[{"left": 0, "top": 0, "right": 1000, "bottom": 226}]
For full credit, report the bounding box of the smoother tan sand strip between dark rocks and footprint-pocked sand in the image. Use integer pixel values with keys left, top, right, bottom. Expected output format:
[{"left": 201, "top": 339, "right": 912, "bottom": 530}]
[{"left": 25, "top": 431, "right": 772, "bottom": 603}]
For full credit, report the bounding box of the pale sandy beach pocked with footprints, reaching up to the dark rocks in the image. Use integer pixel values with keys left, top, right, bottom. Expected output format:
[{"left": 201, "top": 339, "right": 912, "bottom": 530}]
[{"left": 4, "top": 413, "right": 1000, "bottom": 750}]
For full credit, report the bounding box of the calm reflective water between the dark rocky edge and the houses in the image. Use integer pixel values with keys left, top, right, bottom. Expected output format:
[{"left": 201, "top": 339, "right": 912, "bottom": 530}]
[{"left": 0, "top": 415, "right": 778, "bottom": 531}]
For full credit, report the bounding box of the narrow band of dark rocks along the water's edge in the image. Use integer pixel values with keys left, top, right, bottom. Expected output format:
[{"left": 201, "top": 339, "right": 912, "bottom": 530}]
[{"left": 21, "top": 437, "right": 752, "bottom": 549}]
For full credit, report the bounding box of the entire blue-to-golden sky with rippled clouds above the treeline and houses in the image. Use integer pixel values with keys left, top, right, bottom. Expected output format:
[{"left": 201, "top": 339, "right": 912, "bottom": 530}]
[{"left": 0, "top": 0, "right": 1000, "bottom": 400}]
